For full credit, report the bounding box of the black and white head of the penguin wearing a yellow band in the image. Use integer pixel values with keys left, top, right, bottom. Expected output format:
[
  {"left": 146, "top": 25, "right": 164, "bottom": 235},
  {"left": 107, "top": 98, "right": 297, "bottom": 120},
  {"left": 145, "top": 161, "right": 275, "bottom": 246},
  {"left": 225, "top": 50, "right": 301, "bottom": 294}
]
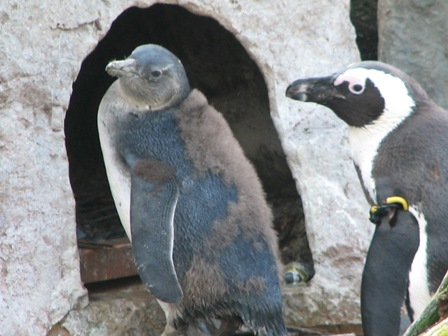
[{"left": 286, "top": 61, "right": 429, "bottom": 127}]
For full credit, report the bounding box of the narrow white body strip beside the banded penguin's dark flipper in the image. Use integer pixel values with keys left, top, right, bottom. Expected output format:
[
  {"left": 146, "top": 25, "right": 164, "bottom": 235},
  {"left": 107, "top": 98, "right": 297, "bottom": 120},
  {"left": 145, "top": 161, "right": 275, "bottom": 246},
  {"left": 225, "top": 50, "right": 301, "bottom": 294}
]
[{"left": 409, "top": 205, "right": 431, "bottom": 319}]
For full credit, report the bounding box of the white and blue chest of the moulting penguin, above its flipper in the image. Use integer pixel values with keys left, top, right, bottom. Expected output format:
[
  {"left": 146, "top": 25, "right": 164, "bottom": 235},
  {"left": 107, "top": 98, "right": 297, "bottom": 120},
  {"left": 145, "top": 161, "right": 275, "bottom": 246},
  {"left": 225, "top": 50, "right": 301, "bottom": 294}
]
[{"left": 98, "top": 103, "right": 191, "bottom": 239}]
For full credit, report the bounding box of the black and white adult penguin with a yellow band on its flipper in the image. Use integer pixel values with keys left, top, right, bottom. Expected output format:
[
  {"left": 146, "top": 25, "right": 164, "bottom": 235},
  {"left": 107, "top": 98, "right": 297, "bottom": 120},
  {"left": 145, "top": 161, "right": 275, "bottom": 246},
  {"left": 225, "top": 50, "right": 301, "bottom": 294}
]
[{"left": 286, "top": 61, "right": 448, "bottom": 336}]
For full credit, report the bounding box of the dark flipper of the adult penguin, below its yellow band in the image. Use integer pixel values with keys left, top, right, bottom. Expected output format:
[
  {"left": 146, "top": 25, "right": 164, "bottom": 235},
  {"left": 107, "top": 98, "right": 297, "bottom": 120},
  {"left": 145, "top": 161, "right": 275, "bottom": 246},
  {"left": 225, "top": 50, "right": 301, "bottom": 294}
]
[{"left": 361, "top": 211, "right": 419, "bottom": 336}]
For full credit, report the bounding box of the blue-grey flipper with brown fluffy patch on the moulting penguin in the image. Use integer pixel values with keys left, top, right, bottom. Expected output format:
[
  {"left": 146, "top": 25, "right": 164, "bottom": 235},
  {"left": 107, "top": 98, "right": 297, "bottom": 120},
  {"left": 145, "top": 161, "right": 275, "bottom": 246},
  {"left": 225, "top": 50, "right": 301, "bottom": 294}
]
[{"left": 128, "top": 159, "right": 183, "bottom": 303}]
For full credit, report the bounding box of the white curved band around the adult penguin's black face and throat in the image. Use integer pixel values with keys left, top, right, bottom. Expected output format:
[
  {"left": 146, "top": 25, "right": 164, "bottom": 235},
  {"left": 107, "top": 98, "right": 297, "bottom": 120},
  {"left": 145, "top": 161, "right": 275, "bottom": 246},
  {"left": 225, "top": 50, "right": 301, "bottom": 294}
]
[{"left": 340, "top": 68, "right": 415, "bottom": 200}]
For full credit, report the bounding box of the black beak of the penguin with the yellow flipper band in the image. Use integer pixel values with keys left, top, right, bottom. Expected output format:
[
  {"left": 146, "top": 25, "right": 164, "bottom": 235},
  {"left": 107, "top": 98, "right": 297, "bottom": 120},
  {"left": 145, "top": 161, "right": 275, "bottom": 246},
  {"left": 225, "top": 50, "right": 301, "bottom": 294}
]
[{"left": 286, "top": 76, "right": 345, "bottom": 105}]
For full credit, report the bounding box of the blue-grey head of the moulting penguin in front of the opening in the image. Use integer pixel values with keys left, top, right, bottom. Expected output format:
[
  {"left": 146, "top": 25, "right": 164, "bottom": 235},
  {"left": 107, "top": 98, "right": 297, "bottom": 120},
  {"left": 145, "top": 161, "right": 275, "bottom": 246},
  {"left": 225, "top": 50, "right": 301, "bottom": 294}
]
[{"left": 106, "top": 44, "right": 191, "bottom": 111}]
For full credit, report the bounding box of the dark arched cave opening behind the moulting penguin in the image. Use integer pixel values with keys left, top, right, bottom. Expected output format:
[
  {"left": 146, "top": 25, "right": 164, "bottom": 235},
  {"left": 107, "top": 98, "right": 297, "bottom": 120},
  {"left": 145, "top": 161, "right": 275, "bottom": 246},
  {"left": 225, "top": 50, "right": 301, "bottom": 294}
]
[{"left": 65, "top": 4, "right": 313, "bottom": 284}]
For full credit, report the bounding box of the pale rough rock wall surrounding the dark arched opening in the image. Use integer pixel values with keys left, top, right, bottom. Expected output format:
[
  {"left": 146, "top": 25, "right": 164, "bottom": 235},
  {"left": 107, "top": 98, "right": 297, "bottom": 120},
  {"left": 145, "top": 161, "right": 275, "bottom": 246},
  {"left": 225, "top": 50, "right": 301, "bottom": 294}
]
[{"left": 0, "top": 0, "right": 371, "bottom": 335}]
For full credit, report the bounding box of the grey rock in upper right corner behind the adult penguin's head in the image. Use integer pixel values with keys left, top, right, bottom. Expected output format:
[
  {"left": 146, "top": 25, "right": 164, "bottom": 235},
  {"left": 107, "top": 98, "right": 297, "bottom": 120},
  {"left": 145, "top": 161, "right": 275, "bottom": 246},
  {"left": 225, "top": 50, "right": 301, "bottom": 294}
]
[{"left": 378, "top": 0, "right": 448, "bottom": 108}]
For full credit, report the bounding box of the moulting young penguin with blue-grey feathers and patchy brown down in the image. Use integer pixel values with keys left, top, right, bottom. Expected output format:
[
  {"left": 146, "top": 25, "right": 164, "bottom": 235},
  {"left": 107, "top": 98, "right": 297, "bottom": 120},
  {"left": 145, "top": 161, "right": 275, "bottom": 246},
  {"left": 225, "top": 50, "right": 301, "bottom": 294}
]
[{"left": 98, "top": 45, "right": 287, "bottom": 336}]
